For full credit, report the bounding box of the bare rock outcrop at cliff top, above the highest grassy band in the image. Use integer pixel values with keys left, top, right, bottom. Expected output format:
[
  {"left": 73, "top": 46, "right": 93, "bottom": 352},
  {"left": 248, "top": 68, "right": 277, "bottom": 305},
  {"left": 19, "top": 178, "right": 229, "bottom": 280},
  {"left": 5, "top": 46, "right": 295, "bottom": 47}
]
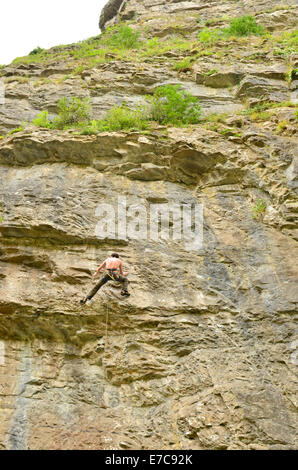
[{"left": 100, "top": 0, "right": 297, "bottom": 36}]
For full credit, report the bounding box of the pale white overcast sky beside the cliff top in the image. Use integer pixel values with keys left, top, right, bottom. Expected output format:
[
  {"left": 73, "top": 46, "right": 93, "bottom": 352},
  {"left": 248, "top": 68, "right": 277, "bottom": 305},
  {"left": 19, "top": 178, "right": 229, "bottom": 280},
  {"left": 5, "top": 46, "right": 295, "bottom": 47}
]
[{"left": 0, "top": 0, "right": 108, "bottom": 64}]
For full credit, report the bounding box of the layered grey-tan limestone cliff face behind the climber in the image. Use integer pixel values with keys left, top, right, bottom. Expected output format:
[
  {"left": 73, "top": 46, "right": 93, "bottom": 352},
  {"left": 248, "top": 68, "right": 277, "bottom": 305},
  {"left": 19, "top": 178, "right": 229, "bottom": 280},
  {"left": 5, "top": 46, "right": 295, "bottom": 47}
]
[{"left": 0, "top": 0, "right": 298, "bottom": 450}]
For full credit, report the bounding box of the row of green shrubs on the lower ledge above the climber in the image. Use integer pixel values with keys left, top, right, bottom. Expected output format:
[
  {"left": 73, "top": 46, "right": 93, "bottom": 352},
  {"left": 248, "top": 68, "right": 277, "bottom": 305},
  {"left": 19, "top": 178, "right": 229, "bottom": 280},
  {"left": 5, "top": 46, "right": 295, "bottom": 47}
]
[{"left": 33, "top": 85, "right": 201, "bottom": 135}]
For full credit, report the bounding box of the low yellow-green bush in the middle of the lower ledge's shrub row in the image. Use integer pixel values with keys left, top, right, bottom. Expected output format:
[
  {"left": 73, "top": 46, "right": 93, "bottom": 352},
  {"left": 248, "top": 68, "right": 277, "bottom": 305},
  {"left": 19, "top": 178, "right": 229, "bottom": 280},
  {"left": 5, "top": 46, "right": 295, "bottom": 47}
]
[{"left": 97, "top": 105, "right": 148, "bottom": 131}]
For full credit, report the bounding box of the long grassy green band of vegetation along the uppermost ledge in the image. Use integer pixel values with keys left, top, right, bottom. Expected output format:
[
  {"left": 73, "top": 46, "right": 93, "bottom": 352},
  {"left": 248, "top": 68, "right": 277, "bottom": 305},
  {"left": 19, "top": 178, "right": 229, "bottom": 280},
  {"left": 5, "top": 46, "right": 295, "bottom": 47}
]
[{"left": 6, "top": 15, "right": 298, "bottom": 70}]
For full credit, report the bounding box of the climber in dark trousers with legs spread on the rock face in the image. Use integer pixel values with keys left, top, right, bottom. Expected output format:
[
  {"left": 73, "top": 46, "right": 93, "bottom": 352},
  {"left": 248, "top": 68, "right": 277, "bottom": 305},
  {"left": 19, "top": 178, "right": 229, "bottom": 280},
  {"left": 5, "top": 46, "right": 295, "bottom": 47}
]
[{"left": 80, "top": 253, "right": 130, "bottom": 304}]
